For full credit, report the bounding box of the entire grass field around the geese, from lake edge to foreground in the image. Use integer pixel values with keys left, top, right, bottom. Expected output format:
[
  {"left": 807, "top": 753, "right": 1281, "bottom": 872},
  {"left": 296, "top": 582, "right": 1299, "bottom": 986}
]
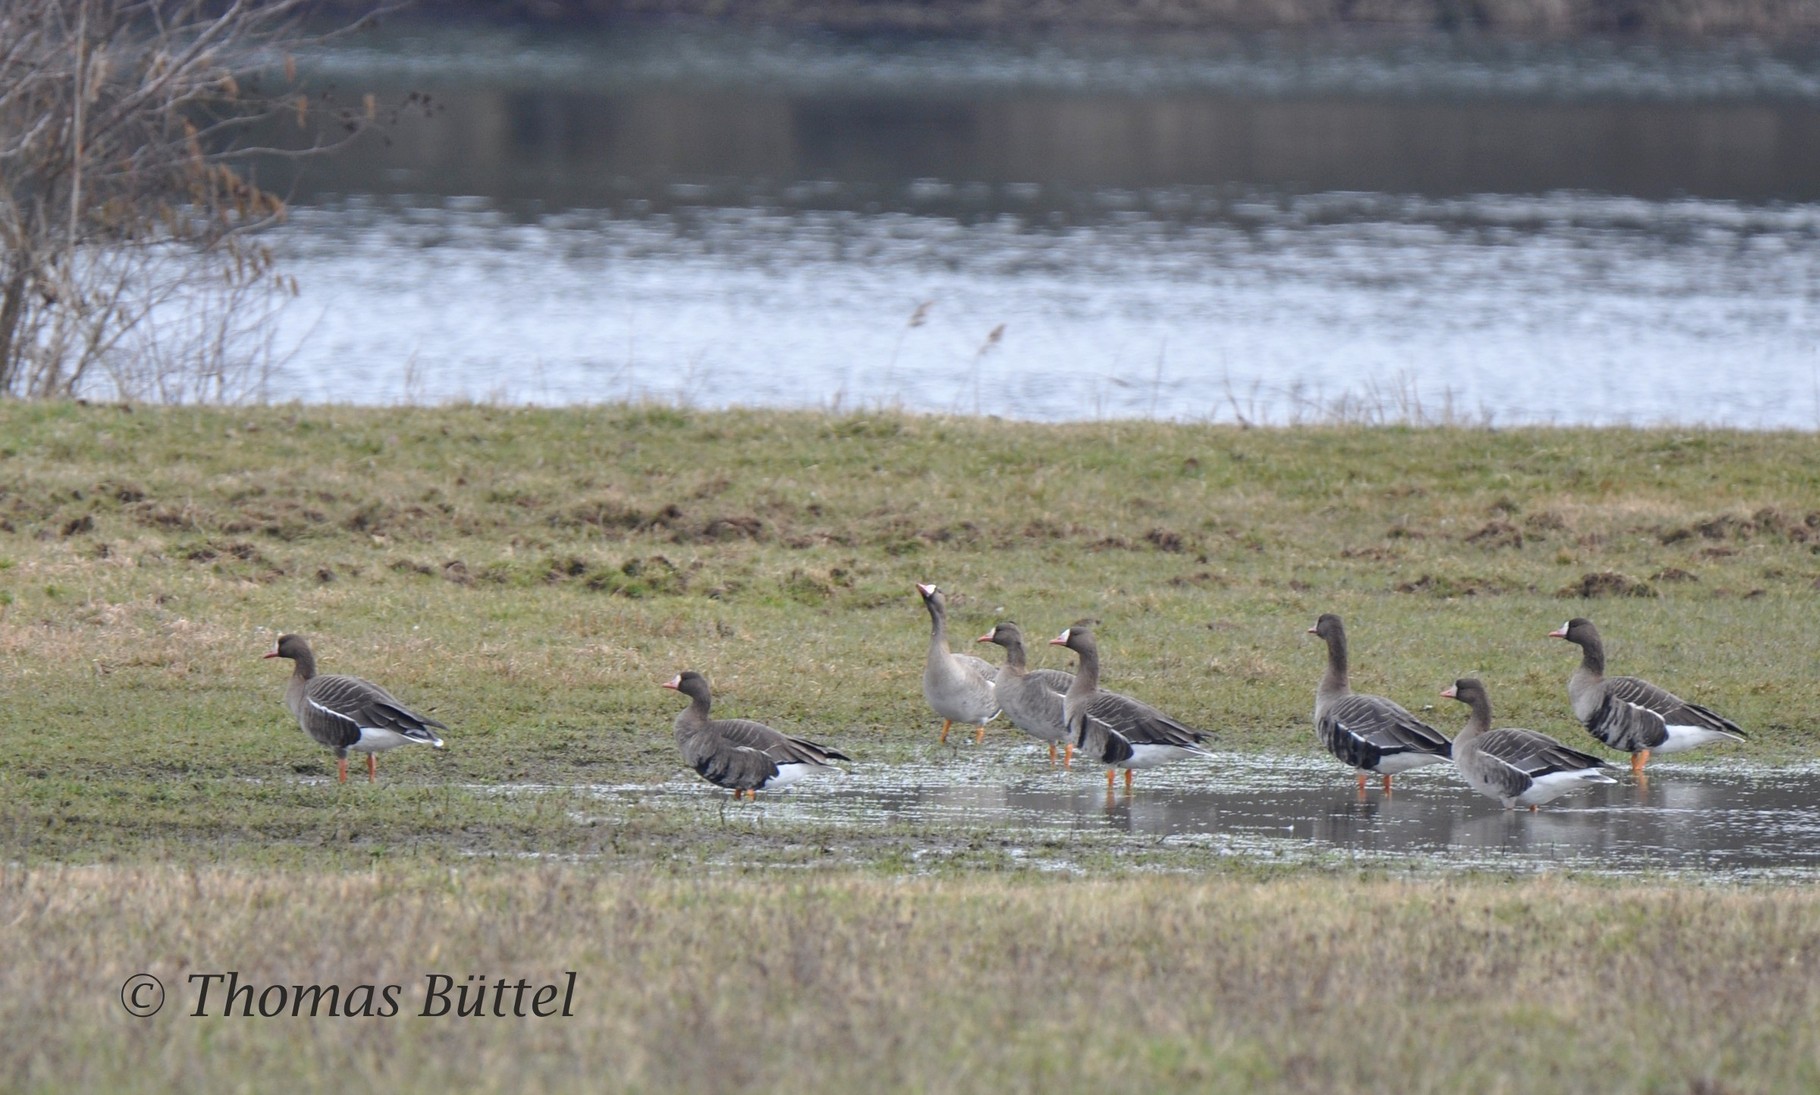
[{"left": 0, "top": 404, "right": 1820, "bottom": 1091}]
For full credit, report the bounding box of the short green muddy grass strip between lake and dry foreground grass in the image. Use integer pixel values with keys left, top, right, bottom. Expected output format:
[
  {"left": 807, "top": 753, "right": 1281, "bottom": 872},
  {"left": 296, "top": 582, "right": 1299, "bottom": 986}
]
[{"left": 0, "top": 404, "right": 1820, "bottom": 860}]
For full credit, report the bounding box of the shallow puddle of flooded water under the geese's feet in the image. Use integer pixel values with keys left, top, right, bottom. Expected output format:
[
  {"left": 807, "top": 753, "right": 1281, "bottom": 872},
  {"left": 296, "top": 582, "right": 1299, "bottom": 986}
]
[{"left": 622, "top": 749, "right": 1820, "bottom": 880}]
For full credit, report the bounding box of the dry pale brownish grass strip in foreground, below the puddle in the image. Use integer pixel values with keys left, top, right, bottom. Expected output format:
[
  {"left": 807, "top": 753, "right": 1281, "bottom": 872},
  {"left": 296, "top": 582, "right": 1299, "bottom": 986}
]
[{"left": 0, "top": 868, "right": 1820, "bottom": 1093}]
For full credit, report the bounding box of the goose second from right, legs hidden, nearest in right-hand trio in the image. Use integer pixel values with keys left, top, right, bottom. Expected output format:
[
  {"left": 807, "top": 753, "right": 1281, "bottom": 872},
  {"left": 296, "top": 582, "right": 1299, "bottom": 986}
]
[{"left": 1441, "top": 677, "right": 1618, "bottom": 811}]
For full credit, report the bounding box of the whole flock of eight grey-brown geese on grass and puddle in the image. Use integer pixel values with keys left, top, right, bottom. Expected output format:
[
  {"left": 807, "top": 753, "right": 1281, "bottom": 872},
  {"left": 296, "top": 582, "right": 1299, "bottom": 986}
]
[{"left": 266, "top": 584, "right": 1744, "bottom": 809}]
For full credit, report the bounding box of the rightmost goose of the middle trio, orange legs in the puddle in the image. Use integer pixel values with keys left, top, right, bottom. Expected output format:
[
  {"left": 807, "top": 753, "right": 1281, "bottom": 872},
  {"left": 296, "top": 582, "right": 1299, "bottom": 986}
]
[{"left": 1048, "top": 624, "right": 1212, "bottom": 791}]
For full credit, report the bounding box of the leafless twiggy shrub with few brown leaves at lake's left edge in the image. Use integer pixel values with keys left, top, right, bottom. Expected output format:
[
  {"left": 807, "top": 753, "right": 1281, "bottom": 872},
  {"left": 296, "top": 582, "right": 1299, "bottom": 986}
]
[{"left": 0, "top": 0, "right": 396, "bottom": 402}]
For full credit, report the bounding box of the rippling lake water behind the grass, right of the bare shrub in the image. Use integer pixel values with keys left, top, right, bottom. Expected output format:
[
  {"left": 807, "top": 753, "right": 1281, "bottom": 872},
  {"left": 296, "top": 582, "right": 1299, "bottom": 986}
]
[{"left": 266, "top": 27, "right": 1820, "bottom": 421}]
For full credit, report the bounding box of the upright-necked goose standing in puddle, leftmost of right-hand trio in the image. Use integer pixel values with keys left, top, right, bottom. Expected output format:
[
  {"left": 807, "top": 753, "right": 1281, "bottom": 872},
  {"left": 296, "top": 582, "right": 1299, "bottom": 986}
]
[{"left": 1309, "top": 613, "right": 1452, "bottom": 793}]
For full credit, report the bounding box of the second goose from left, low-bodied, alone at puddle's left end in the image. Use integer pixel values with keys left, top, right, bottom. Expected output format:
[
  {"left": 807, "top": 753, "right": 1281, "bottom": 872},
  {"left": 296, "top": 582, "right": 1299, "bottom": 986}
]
[{"left": 662, "top": 669, "right": 852, "bottom": 800}]
